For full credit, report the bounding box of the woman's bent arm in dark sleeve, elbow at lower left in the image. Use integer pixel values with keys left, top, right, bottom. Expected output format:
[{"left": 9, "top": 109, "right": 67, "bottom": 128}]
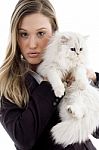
[{"left": 1, "top": 74, "right": 59, "bottom": 149}]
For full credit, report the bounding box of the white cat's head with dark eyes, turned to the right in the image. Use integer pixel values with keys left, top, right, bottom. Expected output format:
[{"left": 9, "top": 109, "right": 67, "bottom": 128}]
[{"left": 55, "top": 32, "right": 87, "bottom": 60}]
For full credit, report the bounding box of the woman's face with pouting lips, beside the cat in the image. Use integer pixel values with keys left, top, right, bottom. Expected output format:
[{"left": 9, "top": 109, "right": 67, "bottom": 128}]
[{"left": 18, "top": 13, "right": 52, "bottom": 65}]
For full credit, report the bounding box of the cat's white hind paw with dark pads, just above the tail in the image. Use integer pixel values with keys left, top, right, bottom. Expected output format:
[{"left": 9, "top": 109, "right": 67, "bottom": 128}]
[{"left": 67, "top": 105, "right": 85, "bottom": 119}]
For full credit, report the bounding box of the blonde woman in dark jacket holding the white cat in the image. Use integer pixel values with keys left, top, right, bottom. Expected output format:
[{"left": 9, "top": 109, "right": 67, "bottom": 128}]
[{"left": 0, "top": 0, "right": 99, "bottom": 150}]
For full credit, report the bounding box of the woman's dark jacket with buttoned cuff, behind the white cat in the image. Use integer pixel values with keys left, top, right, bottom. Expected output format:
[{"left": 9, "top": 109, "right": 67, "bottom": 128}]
[{"left": 1, "top": 74, "right": 99, "bottom": 150}]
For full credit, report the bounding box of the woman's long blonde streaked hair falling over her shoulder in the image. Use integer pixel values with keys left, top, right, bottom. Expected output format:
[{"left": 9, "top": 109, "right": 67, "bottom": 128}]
[{"left": 0, "top": 0, "right": 58, "bottom": 107}]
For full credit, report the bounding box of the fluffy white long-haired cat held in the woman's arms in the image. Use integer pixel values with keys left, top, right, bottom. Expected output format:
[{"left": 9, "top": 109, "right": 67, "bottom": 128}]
[{"left": 37, "top": 32, "right": 99, "bottom": 147}]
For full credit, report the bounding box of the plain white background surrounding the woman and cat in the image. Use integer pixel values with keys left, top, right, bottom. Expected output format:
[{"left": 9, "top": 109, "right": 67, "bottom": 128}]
[{"left": 0, "top": 0, "right": 99, "bottom": 150}]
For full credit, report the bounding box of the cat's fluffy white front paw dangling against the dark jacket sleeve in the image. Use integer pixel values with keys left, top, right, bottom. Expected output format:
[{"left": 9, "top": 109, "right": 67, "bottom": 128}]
[{"left": 54, "top": 84, "right": 65, "bottom": 98}]
